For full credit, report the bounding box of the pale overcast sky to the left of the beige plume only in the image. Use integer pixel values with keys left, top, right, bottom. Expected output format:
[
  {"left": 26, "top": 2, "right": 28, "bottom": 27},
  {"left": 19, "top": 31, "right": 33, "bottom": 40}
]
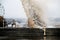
[{"left": 2, "top": 0, "right": 26, "bottom": 18}]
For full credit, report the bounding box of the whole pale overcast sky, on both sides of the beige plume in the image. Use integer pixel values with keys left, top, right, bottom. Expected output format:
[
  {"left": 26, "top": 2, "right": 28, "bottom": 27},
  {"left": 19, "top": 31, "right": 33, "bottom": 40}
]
[{"left": 2, "top": 0, "right": 60, "bottom": 18}]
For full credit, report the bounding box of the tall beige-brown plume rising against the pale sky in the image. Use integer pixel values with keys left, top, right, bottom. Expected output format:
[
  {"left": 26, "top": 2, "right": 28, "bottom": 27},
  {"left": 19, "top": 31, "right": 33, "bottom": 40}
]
[{"left": 22, "top": 0, "right": 47, "bottom": 26}]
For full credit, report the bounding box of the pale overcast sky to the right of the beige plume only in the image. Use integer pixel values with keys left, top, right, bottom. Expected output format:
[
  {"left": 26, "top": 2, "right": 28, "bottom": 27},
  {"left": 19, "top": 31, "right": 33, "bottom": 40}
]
[{"left": 46, "top": 0, "right": 60, "bottom": 18}]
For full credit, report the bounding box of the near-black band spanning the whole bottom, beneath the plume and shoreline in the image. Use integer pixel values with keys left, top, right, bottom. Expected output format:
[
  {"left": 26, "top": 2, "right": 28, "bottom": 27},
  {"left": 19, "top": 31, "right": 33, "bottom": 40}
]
[{"left": 0, "top": 28, "right": 60, "bottom": 40}]
